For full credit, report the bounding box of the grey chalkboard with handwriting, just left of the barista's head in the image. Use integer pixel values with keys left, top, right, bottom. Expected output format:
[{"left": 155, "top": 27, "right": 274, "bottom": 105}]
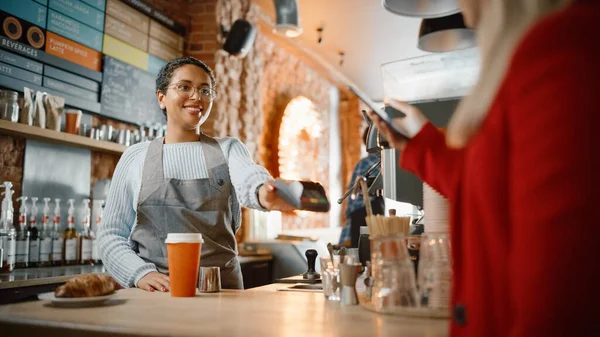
[{"left": 100, "top": 56, "right": 164, "bottom": 125}]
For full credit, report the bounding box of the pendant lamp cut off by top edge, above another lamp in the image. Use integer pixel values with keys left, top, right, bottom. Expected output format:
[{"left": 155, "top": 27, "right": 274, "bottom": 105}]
[{"left": 381, "top": 0, "right": 460, "bottom": 18}]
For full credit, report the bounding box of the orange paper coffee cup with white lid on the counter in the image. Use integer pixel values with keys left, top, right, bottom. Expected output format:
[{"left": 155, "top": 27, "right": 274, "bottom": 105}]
[{"left": 165, "top": 233, "right": 204, "bottom": 297}]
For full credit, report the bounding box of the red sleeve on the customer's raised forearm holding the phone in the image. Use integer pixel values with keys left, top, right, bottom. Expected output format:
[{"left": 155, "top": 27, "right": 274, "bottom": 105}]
[{"left": 400, "top": 123, "right": 464, "bottom": 199}]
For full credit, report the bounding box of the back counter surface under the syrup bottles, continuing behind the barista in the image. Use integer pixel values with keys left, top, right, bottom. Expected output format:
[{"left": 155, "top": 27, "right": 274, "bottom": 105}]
[{"left": 0, "top": 255, "right": 273, "bottom": 290}]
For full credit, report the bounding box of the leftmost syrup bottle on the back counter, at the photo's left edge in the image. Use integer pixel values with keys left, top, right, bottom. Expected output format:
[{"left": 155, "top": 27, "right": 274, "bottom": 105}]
[{"left": 0, "top": 181, "right": 17, "bottom": 273}]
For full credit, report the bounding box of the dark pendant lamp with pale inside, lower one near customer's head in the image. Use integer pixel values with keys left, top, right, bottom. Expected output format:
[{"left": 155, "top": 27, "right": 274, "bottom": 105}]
[{"left": 417, "top": 13, "right": 477, "bottom": 53}]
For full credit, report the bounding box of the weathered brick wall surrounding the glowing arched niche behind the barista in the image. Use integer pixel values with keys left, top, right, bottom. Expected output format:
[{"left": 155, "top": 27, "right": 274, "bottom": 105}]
[{"left": 213, "top": 0, "right": 362, "bottom": 231}]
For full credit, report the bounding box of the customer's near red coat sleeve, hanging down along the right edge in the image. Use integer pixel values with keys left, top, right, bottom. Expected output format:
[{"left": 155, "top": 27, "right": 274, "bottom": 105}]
[{"left": 505, "top": 5, "right": 600, "bottom": 337}]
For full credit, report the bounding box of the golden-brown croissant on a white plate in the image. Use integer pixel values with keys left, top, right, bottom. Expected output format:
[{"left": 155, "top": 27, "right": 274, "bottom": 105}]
[{"left": 54, "top": 274, "right": 120, "bottom": 297}]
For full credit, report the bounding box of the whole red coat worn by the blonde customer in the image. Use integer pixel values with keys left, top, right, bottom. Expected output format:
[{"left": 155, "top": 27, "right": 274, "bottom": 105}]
[{"left": 400, "top": 1, "right": 600, "bottom": 337}]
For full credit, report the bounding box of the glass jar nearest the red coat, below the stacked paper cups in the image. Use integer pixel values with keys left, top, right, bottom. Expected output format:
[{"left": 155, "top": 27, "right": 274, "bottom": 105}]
[{"left": 418, "top": 234, "right": 452, "bottom": 310}]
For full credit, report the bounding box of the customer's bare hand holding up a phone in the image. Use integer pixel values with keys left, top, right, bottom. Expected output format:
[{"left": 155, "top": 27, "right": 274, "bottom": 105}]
[{"left": 369, "top": 100, "right": 428, "bottom": 150}]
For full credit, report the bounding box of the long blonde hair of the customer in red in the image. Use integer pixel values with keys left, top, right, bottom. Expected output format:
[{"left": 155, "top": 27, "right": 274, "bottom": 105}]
[{"left": 446, "top": 0, "right": 574, "bottom": 148}]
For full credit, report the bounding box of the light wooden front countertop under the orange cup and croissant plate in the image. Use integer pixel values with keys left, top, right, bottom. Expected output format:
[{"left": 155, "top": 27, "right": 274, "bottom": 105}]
[{"left": 0, "top": 288, "right": 448, "bottom": 337}]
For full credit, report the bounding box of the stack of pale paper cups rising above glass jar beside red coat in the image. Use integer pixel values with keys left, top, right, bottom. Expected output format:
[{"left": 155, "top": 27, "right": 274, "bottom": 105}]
[{"left": 423, "top": 183, "right": 450, "bottom": 233}]
